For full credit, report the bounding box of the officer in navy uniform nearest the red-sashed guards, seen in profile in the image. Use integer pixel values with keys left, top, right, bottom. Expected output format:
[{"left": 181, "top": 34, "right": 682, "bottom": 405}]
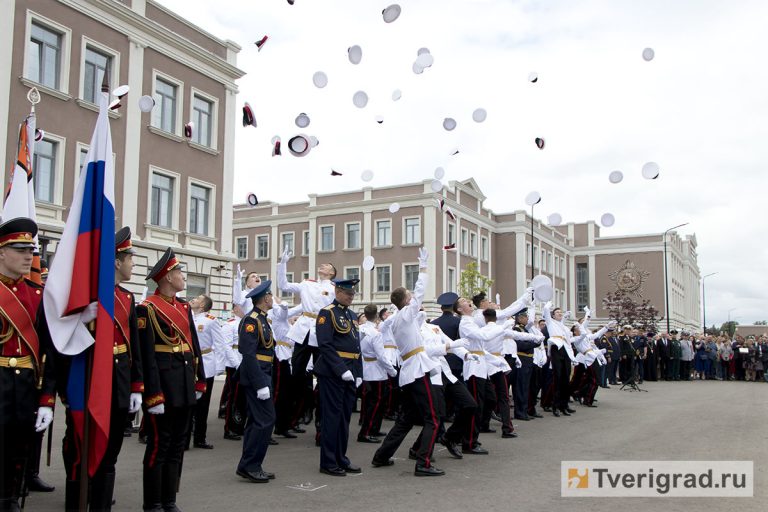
[{"left": 236, "top": 280, "right": 275, "bottom": 483}]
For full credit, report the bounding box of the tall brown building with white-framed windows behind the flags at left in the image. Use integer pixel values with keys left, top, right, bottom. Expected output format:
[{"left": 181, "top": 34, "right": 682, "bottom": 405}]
[{"left": 0, "top": 0, "right": 244, "bottom": 309}]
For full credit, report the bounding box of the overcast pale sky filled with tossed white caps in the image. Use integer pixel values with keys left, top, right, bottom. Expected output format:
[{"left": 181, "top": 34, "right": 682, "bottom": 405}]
[{"left": 161, "top": 0, "right": 768, "bottom": 324}]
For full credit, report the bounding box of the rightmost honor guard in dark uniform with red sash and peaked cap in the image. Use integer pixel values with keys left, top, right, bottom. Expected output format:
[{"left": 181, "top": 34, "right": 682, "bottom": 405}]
[{"left": 136, "top": 248, "right": 205, "bottom": 512}]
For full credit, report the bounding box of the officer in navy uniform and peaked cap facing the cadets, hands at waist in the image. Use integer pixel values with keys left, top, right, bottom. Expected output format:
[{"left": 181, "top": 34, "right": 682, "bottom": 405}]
[{"left": 314, "top": 279, "right": 363, "bottom": 476}]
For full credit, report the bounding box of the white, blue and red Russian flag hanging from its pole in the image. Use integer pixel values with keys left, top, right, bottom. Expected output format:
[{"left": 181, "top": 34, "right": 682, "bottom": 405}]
[{"left": 43, "top": 83, "right": 115, "bottom": 476}]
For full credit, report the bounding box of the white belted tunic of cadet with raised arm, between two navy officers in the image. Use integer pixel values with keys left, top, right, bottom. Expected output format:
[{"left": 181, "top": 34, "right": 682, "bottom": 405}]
[{"left": 277, "top": 263, "right": 336, "bottom": 347}]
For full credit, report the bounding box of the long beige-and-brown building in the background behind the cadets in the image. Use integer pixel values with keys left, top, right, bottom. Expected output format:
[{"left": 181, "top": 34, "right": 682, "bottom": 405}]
[{"left": 233, "top": 179, "right": 701, "bottom": 331}]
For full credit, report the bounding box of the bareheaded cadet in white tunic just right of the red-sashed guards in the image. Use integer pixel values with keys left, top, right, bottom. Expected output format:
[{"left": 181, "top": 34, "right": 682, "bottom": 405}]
[{"left": 189, "top": 295, "right": 227, "bottom": 450}]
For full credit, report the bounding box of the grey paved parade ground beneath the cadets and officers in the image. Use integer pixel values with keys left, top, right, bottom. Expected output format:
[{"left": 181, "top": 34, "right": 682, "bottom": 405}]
[{"left": 27, "top": 381, "right": 768, "bottom": 512}]
